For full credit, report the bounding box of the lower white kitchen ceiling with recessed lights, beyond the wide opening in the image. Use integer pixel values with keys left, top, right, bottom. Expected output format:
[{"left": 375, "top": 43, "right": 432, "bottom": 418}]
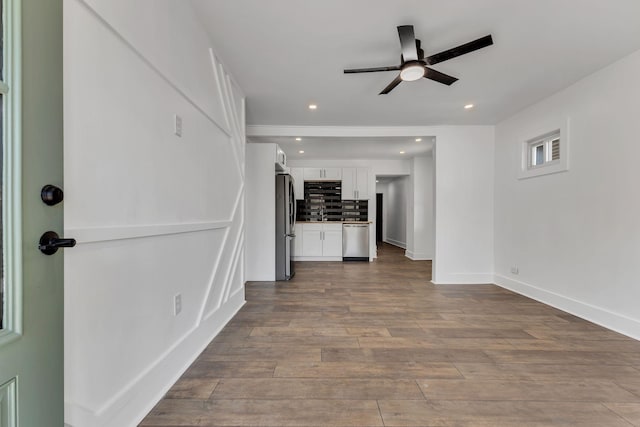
[{"left": 250, "top": 136, "right": 434, "bottom": 160}]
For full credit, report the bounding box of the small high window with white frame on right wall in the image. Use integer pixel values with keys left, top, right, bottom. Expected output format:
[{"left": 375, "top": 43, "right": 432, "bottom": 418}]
[{"left": 518, "top": 118, "right": 569, "bottom": 179}]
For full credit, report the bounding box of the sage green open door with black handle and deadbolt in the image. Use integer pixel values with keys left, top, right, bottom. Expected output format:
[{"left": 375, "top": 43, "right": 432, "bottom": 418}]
[{"left": 0, "top": 0, "right": 64, "bottom": 427}]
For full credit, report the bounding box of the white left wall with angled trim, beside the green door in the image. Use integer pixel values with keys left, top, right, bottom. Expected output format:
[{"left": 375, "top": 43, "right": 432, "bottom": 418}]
[{"left": 64, "top": 0, "right": 244, "bottom": 427}]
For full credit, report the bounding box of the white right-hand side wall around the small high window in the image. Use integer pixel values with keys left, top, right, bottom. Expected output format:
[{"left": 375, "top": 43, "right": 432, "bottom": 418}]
[{"left": 495, "top": 51, "right": 640, "bottom": 338}]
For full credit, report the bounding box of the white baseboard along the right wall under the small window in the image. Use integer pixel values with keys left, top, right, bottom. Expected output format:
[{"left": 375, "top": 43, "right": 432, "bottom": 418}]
[{"left": 495, "top": 274, "right": 640, "bottom": 340}]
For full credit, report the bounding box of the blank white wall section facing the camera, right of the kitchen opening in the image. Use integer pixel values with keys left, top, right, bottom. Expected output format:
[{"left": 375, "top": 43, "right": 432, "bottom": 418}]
[{"left": 433, "top": 126, "right": 494, "bottom": 284}]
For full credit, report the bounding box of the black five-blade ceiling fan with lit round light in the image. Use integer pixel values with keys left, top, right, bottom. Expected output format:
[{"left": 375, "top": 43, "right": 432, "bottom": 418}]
[{"left": 344, "top": 25, "right": 493, "bottom": 95}]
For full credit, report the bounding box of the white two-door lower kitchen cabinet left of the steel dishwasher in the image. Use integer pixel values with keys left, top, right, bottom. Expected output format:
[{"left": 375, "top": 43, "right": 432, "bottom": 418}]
[{"left": 294, "top": 223, "right": 342, "bottom": 261}]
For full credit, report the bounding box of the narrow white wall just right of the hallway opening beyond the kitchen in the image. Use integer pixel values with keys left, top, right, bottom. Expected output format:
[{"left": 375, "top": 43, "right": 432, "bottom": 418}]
[{"left": 406, "top": 155, "right": 435, "bottom": 260}]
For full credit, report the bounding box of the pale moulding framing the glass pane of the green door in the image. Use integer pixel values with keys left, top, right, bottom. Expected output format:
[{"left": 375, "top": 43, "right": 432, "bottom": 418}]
[{"left": 0, "top": 0, "right": 23, "bottom": 346}]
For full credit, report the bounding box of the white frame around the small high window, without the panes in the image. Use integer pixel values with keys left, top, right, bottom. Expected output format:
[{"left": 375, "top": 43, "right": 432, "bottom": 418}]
[{"left": 518, "top": 118, "right": 569, "bottom": 179}]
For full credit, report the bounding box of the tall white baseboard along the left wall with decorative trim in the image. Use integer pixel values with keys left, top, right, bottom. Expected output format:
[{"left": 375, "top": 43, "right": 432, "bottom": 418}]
[{"left": 65, "top": 287, "right": 245, "bottom": 427}]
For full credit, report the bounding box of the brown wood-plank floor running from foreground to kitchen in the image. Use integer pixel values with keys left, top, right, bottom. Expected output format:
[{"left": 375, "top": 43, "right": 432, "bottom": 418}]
[{"left": 141, "top": 245, "right": 640, "bottom": 427}]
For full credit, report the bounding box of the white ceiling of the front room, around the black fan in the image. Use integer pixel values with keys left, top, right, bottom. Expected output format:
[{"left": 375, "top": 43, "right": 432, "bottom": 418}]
[{"left": 192, "top": 0, "right": 640, "bottom": 126}]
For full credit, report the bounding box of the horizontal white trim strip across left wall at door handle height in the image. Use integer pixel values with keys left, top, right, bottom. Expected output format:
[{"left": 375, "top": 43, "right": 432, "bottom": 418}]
[{"left": 65, "top": 221, "right": 232, "bottom": 244}]
